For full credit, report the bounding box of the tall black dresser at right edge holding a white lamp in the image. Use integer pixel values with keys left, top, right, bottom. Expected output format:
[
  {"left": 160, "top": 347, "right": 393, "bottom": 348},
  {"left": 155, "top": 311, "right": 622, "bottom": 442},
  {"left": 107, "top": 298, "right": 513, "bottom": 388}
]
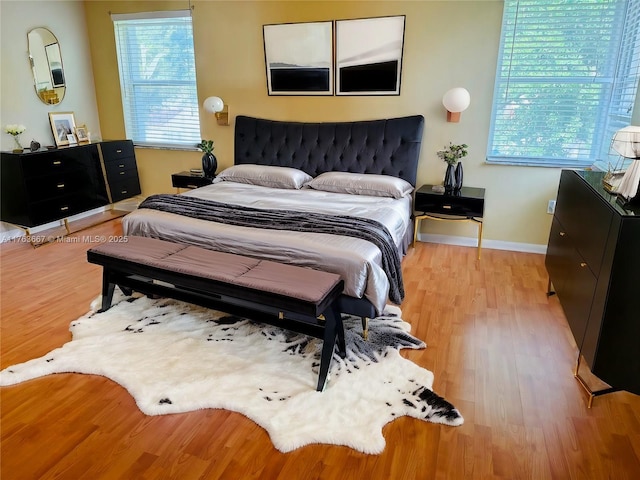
[{"left": 545, "top": 170, "right": 640, "bottom": 394}]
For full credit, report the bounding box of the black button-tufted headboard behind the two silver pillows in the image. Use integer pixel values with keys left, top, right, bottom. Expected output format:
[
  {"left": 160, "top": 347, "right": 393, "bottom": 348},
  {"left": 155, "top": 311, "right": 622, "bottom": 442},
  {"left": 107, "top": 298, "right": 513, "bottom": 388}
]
[{"left": 234, "top": 115, "right": 424, "bottom": 186}]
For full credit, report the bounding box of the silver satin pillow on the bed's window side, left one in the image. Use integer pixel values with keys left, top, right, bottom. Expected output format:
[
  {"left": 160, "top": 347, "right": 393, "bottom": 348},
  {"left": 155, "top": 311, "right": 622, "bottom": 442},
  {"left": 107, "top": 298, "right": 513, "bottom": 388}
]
[{"left": 213, "top": 164, "right": 312, "bottom": 189}]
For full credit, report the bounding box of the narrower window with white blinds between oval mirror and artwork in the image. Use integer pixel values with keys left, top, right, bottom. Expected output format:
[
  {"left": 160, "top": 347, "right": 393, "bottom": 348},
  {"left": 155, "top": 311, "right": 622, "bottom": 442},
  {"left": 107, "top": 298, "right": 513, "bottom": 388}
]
[{"left": 111, "top": 10, "right": 200, "bottom": 148}]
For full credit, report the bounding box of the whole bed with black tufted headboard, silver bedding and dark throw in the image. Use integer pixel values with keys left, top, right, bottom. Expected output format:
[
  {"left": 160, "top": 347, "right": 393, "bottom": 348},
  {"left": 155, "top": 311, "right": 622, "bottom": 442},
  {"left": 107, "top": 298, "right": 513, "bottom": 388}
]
[{"left": 123, "top": 115, "right": 424, "bottom": 318}]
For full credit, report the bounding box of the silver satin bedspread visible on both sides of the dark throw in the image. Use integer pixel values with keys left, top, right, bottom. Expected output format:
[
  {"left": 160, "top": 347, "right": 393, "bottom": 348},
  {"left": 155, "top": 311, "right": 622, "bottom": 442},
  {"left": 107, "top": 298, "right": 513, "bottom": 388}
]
[{"left": 122, "top": 182, "right": 411, "bottom": 312}]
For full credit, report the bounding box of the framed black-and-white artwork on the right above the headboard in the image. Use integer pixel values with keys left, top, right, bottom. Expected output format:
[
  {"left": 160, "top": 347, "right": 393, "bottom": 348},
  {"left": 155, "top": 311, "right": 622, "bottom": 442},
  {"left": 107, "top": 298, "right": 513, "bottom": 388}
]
[{"left": 336, "top": 15, "right": 405, "bottom": 95}]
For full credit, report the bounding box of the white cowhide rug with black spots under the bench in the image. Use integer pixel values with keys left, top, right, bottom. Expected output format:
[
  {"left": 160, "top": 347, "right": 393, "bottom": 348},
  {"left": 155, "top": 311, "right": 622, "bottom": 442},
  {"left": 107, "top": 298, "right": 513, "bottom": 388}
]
[{"left": 0, "top": 296, "right": 463, "bottom": 454}]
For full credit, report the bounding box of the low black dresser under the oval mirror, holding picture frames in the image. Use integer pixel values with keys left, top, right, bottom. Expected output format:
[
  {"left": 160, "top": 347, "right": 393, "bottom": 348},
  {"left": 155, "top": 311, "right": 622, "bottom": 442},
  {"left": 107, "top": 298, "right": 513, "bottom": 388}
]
[{"left": 0, "top": 140, "right": 141, "bottom": 227}]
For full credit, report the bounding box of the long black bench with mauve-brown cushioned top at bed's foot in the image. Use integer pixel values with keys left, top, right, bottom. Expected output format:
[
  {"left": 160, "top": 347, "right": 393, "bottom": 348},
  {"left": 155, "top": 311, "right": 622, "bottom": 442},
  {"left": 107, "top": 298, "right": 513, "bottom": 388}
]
[{"left": 87, "top": 236, "right": 345, "bottom": 391}]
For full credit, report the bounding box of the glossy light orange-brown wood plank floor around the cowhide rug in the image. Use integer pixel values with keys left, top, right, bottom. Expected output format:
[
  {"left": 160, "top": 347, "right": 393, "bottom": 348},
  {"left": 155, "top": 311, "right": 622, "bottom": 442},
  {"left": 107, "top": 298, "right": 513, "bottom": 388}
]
[{"left": 0, "top": 220, "right": 640, "bottom": 480}]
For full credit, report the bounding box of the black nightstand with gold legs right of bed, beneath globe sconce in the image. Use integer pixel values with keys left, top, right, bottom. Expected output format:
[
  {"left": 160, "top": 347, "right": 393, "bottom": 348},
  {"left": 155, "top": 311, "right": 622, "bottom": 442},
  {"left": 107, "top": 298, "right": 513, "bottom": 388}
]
[{"left": 413, "top": 185, "right": 484, "bottom": 258}]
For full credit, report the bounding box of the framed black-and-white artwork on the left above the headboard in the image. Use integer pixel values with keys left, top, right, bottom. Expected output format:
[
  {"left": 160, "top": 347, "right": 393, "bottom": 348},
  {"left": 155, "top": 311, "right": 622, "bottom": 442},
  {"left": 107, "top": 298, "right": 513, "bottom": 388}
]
[{"left": 262, "top": 22, "right": 333, "bottom": 95}]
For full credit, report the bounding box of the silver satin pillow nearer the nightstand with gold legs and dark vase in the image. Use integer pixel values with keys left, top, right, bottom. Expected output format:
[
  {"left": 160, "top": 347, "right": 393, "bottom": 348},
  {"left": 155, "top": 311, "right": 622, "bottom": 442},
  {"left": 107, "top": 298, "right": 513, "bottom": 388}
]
[{"left": 306, "top": 172, "right": 413, "bottom": 198}]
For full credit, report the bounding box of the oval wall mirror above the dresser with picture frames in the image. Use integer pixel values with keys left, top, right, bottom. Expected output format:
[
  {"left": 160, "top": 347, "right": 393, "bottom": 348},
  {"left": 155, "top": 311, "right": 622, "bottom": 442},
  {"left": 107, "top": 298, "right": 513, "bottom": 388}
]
[{"left": 27, "top": 27, "right": 66, "bottom": 105}]
